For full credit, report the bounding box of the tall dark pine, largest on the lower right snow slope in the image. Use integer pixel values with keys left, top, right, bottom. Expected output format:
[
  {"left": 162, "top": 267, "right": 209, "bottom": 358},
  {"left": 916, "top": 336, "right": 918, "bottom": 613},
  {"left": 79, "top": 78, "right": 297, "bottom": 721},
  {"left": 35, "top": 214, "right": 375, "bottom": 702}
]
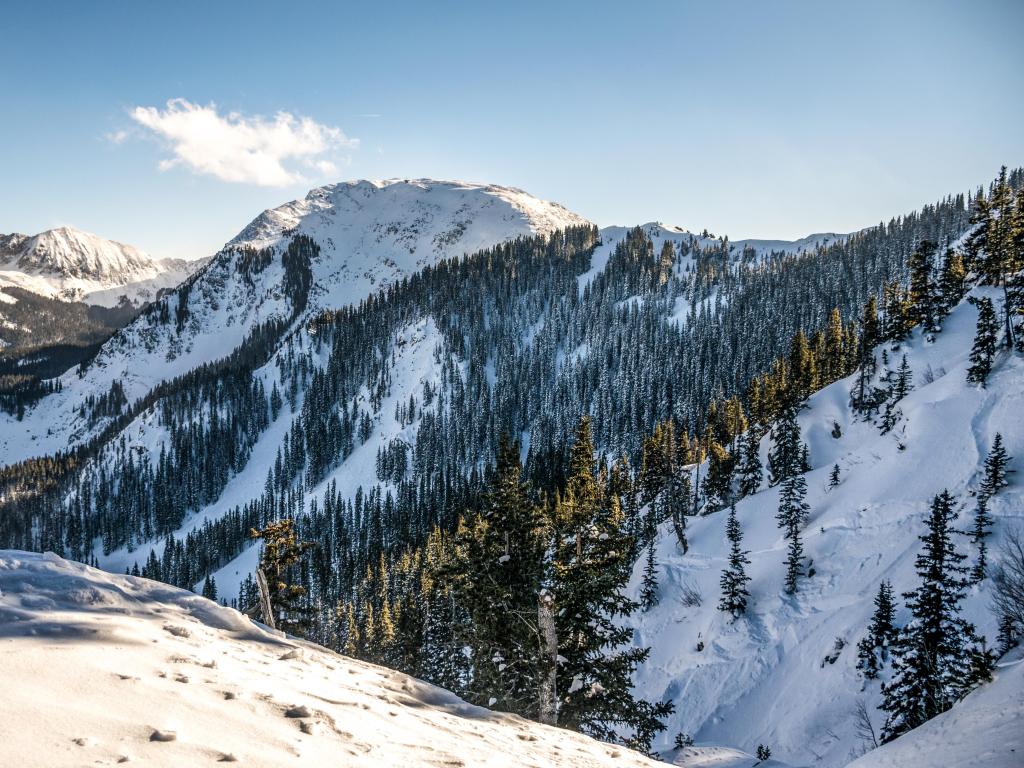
[{"left": 882, "top": 490, "right": 981, "bottom": 741}]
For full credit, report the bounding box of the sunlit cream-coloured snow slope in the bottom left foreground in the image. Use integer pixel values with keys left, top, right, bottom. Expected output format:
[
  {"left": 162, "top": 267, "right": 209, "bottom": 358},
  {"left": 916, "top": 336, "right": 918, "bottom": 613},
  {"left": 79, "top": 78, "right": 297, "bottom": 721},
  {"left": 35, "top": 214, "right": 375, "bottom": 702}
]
[{"left": 0, "top": 551, "right": 655, "bottom": 768}]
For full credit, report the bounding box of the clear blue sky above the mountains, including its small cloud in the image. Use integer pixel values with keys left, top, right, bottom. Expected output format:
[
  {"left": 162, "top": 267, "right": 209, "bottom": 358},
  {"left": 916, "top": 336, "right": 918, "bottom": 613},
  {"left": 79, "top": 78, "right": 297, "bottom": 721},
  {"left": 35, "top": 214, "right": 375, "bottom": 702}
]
[{"left": 0, "top": 0, "right": 1024, "bottom": 257}]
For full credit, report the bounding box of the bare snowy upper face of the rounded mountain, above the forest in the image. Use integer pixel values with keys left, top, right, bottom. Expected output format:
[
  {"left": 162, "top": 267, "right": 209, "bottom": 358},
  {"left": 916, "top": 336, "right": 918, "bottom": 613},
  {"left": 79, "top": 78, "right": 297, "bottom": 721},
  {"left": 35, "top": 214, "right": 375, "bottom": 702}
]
[{"left": 0, "top": 179, "right": 588, "bottom": 465}]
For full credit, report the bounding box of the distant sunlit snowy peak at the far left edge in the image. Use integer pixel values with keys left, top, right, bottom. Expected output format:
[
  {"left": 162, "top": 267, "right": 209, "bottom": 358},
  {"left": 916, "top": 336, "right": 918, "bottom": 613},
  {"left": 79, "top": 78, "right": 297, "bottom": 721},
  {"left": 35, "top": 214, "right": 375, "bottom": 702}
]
[{"left": 0, "top": 226, "right": 202, "bottom": 306}]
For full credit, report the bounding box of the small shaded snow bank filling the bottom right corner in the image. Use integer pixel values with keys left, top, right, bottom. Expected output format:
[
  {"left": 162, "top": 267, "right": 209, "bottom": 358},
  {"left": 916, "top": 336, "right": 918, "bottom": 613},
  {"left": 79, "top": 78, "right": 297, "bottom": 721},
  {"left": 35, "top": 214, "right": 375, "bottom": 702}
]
[{"left": 849, "top": 653, "right": 1024, "bottom": 768}]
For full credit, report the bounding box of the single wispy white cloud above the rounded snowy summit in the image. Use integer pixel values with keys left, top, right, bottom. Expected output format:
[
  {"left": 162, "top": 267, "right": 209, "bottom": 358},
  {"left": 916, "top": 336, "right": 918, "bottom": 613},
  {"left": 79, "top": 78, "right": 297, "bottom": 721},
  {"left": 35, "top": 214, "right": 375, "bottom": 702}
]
[{"left": 131, "top": 98, "right": 358, "bottom": 186}]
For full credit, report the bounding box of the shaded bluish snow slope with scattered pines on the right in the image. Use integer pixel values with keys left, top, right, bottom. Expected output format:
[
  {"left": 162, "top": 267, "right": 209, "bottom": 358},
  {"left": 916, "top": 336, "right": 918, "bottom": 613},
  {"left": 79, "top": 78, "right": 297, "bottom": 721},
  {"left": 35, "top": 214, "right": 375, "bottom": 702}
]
[{"left": 633, "top": 286, "right": 1024, "bottom": 766}]
